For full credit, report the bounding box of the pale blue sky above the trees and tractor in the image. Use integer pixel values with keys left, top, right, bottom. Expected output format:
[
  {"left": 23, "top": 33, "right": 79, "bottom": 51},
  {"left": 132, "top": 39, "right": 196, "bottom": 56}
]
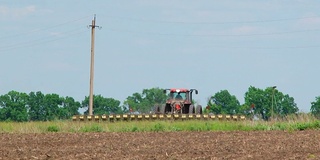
[{"left": 0, "top": 0, "right": 320, "bottom": 112}]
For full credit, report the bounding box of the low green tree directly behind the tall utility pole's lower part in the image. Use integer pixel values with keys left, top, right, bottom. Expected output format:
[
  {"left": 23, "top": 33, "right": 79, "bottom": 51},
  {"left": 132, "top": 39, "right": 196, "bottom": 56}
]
[{"left": 82, "top": 95, "right": 122, "bottom": 115}]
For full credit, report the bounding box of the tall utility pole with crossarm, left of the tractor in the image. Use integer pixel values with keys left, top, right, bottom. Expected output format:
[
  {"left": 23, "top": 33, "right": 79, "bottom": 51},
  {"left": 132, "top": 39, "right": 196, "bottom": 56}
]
[{"left": 89, "top": 15, "right": 99, "bottom": 115}]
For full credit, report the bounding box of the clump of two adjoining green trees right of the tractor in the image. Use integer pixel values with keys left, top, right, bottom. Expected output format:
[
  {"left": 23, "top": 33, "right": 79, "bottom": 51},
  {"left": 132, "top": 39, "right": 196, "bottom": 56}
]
[{"left": 208, "top": 86, "right": 299, "bottom": 120}]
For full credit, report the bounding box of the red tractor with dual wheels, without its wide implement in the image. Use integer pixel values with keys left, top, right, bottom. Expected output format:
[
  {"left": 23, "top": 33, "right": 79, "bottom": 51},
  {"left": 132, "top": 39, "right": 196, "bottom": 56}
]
[{"left": 155, "top": 88, "right": 202, "bottom": 114}]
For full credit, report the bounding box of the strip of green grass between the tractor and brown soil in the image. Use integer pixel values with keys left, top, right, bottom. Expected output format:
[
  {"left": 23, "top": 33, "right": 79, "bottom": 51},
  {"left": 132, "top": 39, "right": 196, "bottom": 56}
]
[{"left": 0, "top": 120, "right": 320, "bottom": 133}]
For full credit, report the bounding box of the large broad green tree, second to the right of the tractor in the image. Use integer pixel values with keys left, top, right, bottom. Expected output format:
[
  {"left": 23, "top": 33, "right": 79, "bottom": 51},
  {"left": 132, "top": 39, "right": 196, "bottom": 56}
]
[{"left": 245, "top": 86, "right": 299, "bottom": 120}]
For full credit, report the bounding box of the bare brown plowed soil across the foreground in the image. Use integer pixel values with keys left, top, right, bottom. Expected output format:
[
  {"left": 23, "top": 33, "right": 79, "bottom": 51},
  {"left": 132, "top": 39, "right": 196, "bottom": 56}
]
[{"left": 0, "top": 131, "right": 320, "bottom": 160}]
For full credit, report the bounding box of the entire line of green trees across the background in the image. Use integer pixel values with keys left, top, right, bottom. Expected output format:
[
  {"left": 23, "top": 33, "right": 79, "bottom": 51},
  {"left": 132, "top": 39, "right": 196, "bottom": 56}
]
[{"left": 0, "top": 86, "right": 320, "bottom": 122}]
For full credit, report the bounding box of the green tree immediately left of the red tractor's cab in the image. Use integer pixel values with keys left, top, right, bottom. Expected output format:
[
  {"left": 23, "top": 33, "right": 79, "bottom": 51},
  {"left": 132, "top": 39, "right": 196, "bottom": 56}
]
[{"left": 124, "top": 88, "right": 167, "bottom": 113}]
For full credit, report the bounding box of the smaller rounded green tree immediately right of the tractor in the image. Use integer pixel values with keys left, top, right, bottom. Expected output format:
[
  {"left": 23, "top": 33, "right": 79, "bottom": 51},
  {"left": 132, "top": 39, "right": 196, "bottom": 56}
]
[{"left": 208, "top": 90, "right": 240, "bottom": 114}]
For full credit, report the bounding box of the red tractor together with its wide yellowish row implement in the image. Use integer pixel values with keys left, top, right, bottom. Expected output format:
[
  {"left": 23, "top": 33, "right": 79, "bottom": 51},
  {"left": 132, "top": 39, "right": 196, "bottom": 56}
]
[{"left": 72, "top": 88, "right": 246, "bottom": 122}]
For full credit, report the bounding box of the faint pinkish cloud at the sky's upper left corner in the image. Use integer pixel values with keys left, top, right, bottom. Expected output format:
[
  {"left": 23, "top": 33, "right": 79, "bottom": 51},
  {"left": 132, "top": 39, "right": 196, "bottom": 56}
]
[{"left": 0, "top": 5, "right": 36, "bottom": 18}]
